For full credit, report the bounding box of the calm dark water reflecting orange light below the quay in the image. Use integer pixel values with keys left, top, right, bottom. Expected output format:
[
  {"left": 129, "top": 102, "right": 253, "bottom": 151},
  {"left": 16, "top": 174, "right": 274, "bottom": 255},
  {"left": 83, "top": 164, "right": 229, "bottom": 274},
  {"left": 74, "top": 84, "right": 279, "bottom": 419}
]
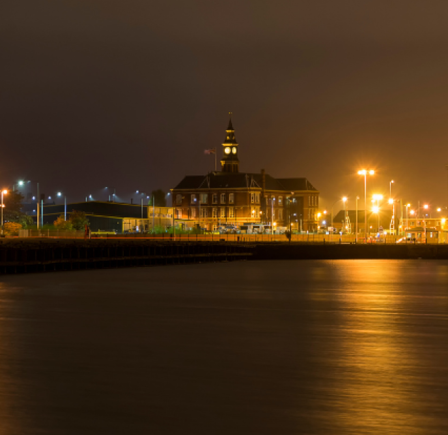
[{"left": 0, "top": 260, "right": 448, "bottom": 435}]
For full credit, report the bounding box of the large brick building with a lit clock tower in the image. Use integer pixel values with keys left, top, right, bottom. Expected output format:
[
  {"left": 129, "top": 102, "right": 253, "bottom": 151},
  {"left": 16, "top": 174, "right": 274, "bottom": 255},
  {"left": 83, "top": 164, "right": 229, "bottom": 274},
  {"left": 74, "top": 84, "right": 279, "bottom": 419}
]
[{"left": 171, "top": 115, "right": 319, "bottom": 232}]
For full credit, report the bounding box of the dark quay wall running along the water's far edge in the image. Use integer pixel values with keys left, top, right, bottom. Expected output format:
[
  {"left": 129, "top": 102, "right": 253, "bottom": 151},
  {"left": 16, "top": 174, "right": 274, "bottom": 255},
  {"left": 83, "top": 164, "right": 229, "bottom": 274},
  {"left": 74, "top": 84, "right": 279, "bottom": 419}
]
[{"left": 0, "top": 239, "right": 448, "bottom": 274}]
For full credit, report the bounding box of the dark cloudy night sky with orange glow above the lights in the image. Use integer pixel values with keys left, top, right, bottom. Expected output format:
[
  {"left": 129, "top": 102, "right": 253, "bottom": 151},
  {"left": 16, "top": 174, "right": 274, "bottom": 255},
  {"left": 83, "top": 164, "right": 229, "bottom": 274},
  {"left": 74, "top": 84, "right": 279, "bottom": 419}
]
[{"left": 0, "top": 0, "right": 448, "bottom": 211}]
